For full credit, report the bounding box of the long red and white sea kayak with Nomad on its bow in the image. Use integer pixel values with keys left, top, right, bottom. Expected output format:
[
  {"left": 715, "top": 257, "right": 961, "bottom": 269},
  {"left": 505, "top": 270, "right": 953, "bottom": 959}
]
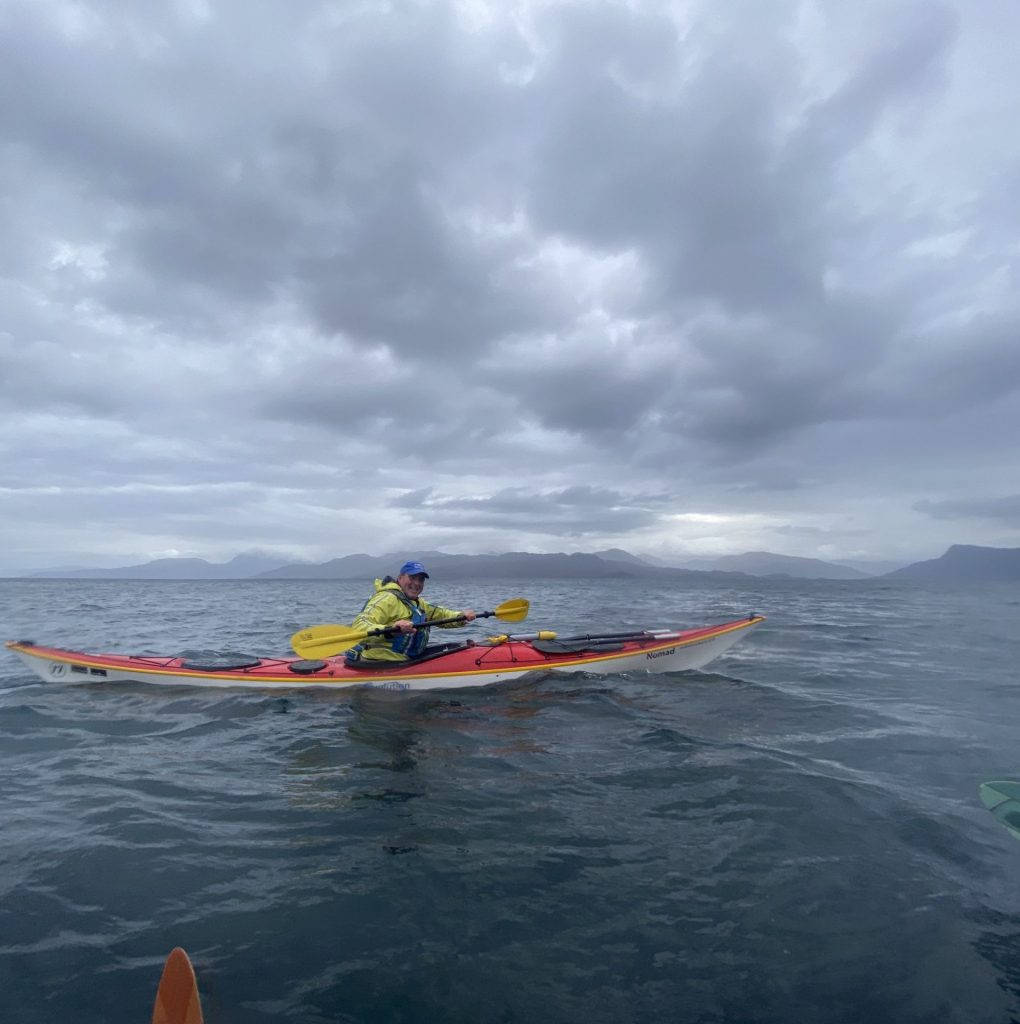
[{"left": 6, "top": 615, "right": 764, "bottom": 690}]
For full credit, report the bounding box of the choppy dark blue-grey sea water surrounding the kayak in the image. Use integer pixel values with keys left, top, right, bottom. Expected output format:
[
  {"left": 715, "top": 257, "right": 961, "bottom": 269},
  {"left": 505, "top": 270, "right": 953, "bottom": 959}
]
[{"left": 0, "top": 581, "right": 1020, "bottom": 1024}]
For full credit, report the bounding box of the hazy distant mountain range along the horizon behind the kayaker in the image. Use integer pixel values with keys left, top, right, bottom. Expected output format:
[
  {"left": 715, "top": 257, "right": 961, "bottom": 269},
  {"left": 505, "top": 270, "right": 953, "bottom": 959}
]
[{"left": 21, "top": 545, "right": 1020, "bottom": 582}]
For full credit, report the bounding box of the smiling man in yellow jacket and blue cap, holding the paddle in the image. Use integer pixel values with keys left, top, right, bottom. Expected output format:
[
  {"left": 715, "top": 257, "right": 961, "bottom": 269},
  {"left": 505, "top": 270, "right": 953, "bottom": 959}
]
[{"left": 345, "top": 562, "right": 475, "bottom": 666}]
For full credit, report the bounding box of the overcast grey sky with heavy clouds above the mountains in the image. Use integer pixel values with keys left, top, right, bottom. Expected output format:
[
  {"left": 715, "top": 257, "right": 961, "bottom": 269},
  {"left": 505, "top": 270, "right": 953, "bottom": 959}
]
[{"left": 0, "top": 0, "right": 1020, "bottom": 574}]
